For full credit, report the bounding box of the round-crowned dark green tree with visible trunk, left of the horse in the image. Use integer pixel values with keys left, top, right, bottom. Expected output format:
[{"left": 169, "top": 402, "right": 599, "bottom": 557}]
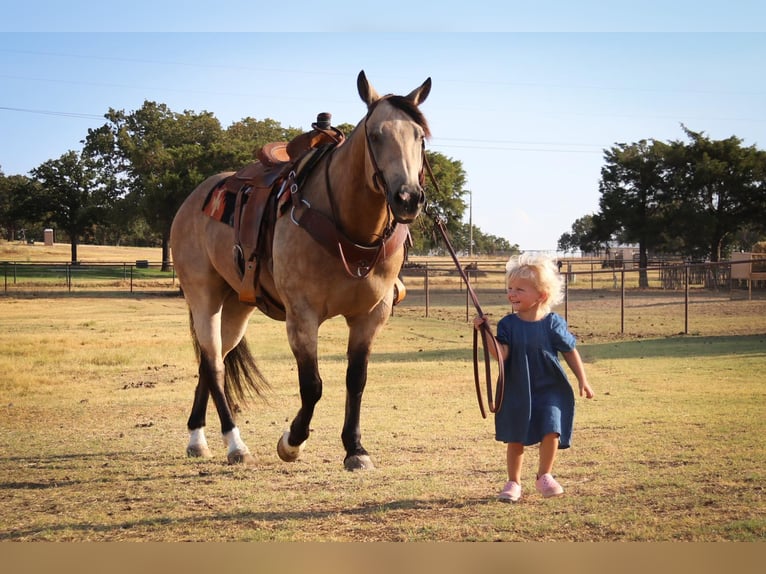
[{"left": 31, "top": 151, "right": 115, "bottom": 263}]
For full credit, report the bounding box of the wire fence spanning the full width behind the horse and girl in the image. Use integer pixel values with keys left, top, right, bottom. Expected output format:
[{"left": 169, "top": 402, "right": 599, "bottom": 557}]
[{"left": 0, "top": 257, "right": 766, "bottom": 335}]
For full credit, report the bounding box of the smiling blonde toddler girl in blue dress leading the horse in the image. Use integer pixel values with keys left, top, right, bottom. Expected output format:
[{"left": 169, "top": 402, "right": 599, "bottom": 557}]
[{"left": 474, "top": 253, "right": 593, "bottom": 502}]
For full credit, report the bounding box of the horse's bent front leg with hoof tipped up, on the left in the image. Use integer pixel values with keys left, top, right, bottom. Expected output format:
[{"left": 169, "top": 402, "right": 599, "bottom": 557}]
[{"left": 277, "top": 316, "right": 322, "bottom": 462}]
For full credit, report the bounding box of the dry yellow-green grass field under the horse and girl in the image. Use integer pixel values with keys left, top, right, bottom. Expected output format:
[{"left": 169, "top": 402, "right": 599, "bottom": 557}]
[{"left": 0, "top": 244, "right": 766, "bottom": 542}]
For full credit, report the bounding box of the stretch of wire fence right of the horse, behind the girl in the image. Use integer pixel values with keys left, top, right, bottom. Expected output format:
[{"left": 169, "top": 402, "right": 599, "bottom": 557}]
[{"left": 394, "top": 259, "right": 766, "bottom": 335}]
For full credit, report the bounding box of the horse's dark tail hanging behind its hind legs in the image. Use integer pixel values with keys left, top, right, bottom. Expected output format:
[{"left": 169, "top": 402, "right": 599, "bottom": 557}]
[{"left": 189, "top": 311, "right": 270, "bottom": 409}]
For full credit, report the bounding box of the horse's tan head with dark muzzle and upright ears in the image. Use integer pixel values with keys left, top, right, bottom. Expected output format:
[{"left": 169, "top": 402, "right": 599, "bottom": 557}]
[{"left": 356, "top": 71, "right": 431, "bottom": 223}]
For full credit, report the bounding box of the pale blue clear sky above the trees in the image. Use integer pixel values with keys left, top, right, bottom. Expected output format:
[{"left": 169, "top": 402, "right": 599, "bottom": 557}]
[{"left": 0, "top": 0, "right": 766, "bottom": 251}]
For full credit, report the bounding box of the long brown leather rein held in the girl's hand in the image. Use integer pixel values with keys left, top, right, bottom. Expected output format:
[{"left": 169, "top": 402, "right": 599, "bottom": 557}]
[{"left": 424, "top": 156, "right": 505, "bottom": 418}]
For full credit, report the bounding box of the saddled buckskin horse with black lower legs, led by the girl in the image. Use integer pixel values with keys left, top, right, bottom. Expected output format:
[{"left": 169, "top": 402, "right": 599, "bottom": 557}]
[{"left": 170, "top": 71, "right": 431, "bottom": 470}]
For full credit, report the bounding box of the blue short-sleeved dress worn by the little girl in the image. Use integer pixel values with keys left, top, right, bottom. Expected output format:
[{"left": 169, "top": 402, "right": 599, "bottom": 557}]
[{"left": 495, "top": 313, "right": 575, "bottom": 449}]
